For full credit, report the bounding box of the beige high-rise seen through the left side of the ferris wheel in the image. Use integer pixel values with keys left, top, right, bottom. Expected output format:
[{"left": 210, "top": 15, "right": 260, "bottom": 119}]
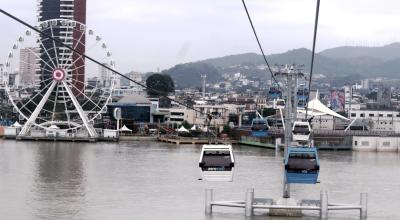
[{"left": 19, "top": 47, "right": 38, "bottom": 85}]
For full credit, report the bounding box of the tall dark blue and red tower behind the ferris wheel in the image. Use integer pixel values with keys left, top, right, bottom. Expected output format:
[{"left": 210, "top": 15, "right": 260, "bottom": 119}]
[{"left": 37, "top": 0, "right": 86, "bottom": 94}]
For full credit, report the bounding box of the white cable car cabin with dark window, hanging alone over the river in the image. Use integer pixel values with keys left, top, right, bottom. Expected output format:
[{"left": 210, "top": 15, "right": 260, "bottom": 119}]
[{"left": 199, "top": 145, "right": 235, "bottom": 181}]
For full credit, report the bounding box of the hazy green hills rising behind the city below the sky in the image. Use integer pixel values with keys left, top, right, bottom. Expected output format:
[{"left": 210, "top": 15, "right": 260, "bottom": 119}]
[{"left": 157, "top": 43, "right": 400, "bottom": 88}]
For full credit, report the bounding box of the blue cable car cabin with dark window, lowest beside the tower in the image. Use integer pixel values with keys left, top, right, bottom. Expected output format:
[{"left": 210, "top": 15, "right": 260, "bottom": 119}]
[{"left": 285, "top": 147, "right": 319, "bottom": 184}]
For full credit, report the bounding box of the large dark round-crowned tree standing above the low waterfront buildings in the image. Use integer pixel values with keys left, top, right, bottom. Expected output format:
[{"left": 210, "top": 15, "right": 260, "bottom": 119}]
[{"left": 146, "top": 73, "right": 175, "bottom": 97}]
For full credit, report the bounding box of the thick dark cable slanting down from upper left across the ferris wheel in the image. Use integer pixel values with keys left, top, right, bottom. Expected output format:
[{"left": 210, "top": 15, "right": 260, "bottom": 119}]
[{"left": 0, "top": 9, "right": 213, "bottom": 122}]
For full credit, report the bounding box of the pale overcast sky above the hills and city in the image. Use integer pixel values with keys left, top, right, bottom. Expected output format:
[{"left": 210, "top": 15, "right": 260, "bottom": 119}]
[{"left": 0, "top": 0, "right": 400, "bottom": 72}]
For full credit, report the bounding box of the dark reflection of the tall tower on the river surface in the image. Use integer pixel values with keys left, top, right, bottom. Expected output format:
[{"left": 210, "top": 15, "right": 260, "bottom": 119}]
[{"left": 31, "top": 142, "right": 86, "bottom": 219}]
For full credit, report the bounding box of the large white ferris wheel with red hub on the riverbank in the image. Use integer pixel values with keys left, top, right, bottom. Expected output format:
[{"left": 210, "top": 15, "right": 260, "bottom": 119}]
[{"left": 2, "top": 19, "right": 115, "bottom": 137}]
